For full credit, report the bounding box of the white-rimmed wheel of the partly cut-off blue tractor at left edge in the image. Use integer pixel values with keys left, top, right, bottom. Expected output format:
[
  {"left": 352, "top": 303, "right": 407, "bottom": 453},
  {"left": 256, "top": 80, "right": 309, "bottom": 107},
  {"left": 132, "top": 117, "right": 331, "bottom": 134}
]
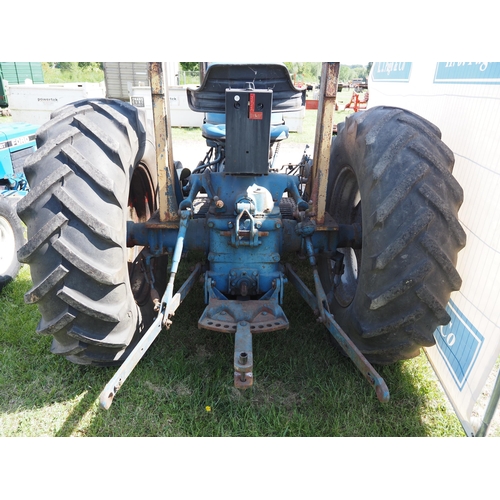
[{"left": 0, "top": 195, "right": 25, "bottom": 291}]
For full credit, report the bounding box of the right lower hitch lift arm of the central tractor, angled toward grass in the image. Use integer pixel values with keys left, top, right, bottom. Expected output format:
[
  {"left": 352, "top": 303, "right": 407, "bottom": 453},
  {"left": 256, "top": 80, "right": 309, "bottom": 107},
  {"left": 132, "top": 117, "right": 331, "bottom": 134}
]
[{"left": 286, "top": 264, "right": 390, "bottom": 403}]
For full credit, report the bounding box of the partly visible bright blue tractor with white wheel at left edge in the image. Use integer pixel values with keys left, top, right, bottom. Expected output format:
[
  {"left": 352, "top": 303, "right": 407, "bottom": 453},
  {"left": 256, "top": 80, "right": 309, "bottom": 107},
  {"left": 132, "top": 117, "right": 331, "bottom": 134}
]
[{"left": 0, "top": 123, "right": 38, "bottom": 290}]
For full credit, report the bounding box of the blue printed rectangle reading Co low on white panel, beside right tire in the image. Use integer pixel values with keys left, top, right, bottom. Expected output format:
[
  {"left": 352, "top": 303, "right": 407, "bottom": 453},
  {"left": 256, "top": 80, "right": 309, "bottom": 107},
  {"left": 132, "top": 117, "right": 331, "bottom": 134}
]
[{"left": 434, "top": 300, "right": 484, "bottom": 390}]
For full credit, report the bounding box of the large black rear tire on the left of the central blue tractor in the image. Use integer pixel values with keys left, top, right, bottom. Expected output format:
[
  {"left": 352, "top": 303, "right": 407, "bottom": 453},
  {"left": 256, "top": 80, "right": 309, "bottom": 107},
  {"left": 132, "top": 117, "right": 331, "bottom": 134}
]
[{"left": 18, "top": 99, "right": 164, "bottom": 365}]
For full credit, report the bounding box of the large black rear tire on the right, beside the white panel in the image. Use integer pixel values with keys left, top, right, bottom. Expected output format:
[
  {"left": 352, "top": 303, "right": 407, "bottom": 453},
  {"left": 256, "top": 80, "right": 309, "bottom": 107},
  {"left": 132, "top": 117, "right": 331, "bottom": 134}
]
[{"left": 319, "top": 107, "right": 466, "bottom": 364}]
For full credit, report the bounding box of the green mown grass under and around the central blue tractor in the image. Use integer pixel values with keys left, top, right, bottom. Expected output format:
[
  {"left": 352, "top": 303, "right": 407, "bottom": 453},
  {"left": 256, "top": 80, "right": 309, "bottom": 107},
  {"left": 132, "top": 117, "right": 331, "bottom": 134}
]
[{"left": 0, "top": 95, "right": 464, "bottom": 437}]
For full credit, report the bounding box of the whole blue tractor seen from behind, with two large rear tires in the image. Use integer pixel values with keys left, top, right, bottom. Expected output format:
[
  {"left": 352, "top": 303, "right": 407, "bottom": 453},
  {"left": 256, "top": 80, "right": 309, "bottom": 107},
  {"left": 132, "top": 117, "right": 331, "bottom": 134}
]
[{"left": 18, "top": 63, "right": 465, "bottom": 408}]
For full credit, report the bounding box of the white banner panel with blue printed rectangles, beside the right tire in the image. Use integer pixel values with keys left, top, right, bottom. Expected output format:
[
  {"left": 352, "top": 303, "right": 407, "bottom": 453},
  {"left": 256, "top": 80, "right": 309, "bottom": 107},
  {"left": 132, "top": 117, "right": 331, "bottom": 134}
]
[{"left": 368, "top": 62, "right": 500, "bottom": 436}]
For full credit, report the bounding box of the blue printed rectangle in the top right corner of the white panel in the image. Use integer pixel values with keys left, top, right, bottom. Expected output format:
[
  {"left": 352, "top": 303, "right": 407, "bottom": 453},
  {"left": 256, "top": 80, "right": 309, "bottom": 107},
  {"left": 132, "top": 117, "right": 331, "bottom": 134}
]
[{"left": 434, "top": 62, "right": 500, "bottom": 84}]
